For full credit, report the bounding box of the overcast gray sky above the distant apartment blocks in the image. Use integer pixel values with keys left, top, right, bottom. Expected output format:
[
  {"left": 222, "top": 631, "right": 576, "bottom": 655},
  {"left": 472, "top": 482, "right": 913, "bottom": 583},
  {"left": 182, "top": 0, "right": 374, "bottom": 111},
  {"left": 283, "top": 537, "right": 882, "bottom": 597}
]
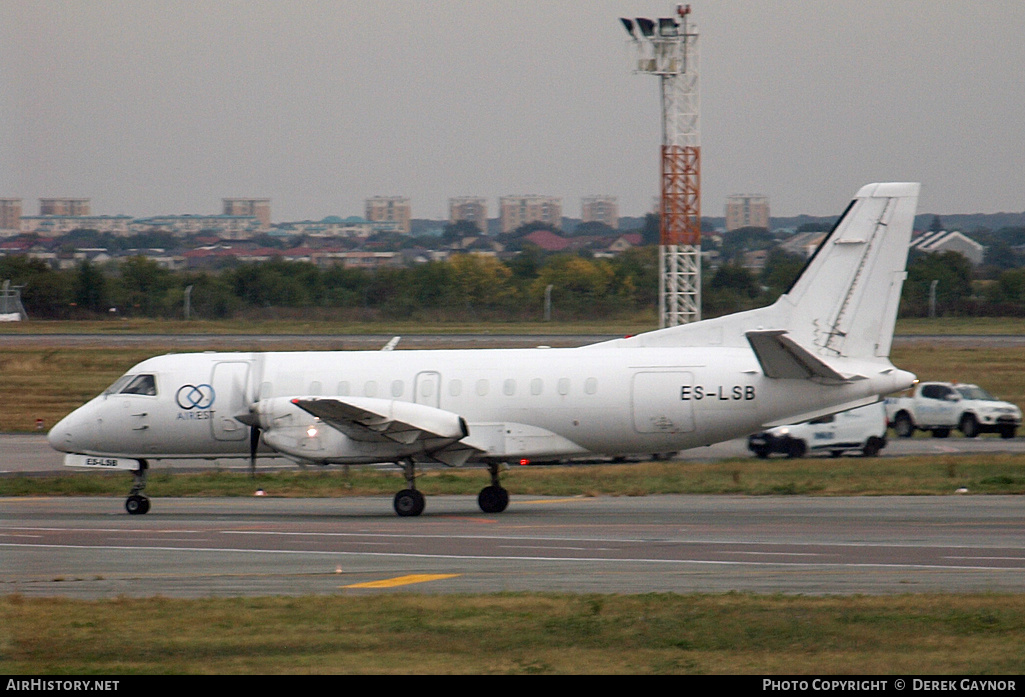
[{"left": 0, "top": 0, "right": 1025, "bottom": 220}]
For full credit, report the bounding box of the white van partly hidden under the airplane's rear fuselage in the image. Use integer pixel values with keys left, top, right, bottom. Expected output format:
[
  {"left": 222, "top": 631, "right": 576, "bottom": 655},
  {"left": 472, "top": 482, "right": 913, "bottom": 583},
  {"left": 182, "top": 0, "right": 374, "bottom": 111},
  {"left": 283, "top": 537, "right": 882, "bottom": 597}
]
[{"left": 747, "top": 402, "right": 887, "bottom": 458}]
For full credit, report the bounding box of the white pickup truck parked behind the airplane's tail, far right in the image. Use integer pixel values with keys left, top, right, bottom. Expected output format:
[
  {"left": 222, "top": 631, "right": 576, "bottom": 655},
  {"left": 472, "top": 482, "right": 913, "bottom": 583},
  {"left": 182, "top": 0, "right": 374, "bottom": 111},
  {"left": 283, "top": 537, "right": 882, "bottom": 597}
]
[{"left": 886, "top": 382, "right": 1022, "bottom": 438}]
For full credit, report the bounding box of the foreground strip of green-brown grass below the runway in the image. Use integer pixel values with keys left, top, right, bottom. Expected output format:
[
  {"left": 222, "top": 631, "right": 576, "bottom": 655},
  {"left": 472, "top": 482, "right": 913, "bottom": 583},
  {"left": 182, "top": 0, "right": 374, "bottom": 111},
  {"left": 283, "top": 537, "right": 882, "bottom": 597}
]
[{"left": 0, "top": 593, "right": 1025, "bottom": 677}]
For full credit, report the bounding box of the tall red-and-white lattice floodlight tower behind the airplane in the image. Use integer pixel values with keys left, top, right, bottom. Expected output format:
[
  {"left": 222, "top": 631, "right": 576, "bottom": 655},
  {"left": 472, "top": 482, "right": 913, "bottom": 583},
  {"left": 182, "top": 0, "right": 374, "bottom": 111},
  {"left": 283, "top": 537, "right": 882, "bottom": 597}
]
[{"left": 620, "top": 5, "right": 701, "bottom": 327}]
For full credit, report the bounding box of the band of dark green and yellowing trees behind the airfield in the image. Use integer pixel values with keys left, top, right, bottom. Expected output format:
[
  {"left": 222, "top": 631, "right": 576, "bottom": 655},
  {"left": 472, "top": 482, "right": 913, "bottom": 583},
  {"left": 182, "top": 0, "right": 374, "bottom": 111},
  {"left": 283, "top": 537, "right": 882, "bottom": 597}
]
[{"left": 0, "top": 246, "right": 1025, "bottom": 321}]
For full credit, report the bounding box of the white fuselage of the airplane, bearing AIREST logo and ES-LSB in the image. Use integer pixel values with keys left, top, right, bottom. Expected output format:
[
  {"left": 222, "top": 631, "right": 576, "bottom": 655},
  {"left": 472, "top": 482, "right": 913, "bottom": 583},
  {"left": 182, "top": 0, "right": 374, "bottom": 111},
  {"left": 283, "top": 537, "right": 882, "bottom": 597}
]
[{"left": 50, "top": 347, "right": 914, "bottom": 463}]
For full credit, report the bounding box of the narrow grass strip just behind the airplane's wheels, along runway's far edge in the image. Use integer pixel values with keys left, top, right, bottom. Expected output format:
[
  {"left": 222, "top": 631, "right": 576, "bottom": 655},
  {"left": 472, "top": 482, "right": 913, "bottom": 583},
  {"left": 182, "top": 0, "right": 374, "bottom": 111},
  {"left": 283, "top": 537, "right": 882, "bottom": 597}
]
[{"left": 6, "top": 454, "right": 1025, "bottom": 498}]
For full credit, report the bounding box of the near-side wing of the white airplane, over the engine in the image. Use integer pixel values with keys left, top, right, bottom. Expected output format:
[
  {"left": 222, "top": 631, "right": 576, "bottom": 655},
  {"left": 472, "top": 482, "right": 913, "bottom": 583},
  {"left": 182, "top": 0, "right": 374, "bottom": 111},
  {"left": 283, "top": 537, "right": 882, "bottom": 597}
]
[{"left": 292, "top": 397, "right": 468, "bottom": 445}]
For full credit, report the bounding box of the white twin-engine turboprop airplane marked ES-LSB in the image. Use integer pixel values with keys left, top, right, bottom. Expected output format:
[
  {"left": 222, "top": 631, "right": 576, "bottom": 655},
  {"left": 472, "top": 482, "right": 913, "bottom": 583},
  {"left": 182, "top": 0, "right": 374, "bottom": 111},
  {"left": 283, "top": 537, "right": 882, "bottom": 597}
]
[{"left": 49, "top": 183, "right": 919, "bottom": 516}]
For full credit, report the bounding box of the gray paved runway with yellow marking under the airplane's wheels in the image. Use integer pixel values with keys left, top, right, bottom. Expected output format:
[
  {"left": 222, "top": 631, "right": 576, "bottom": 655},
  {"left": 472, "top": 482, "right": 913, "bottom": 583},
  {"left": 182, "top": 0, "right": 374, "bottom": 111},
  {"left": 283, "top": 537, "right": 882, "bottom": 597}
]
[{"left": 0, "top": 496, "right": 1025, "bottom": 598}]
